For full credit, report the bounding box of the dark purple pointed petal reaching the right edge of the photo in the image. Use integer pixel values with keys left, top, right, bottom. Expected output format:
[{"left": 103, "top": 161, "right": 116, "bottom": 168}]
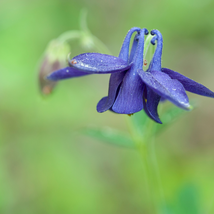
[{"left": 161, "top": 68, "right": 214, "bottom": 98}]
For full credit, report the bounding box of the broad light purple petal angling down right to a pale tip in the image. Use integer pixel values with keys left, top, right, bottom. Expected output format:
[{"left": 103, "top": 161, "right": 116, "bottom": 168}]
[{"left": 138, "top": 69, "right": 190, "bottom": 110}]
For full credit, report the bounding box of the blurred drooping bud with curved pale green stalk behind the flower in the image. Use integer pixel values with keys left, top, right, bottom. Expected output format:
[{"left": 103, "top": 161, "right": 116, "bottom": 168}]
[{"left": 39, "top": 10, "right": 110, "bottom": 95}]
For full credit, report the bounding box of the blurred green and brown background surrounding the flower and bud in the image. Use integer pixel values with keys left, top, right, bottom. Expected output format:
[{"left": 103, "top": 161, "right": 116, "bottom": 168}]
[{"left": 0, "top": 0, "right": 214, "bottom": 214}]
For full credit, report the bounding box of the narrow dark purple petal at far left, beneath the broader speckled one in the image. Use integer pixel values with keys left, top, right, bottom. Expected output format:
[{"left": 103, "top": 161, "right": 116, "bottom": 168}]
[{"left": 46, "top": 67, "right": 90, "bottom": 81}]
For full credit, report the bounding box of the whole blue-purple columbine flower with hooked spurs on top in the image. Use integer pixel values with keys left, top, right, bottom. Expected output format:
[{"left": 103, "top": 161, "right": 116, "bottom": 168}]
[{"left": 47, "top": 28, "right": 214, "bottom": 123}]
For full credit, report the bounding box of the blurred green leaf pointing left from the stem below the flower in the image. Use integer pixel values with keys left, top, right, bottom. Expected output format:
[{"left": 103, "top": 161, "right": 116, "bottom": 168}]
[{"left": 81, "top": 127, "right": 135, "bottom": 149}]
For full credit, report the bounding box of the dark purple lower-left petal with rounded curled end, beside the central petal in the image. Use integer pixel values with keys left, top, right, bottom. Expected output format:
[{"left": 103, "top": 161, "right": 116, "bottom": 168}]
[{"left": 97, "top": 72, "right": 126, "bottom": 113}]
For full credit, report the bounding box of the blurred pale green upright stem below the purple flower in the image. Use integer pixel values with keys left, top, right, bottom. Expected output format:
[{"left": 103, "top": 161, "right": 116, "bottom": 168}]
[{"left": 127, "top": 115, "right": 165, "bottom": 214}]
